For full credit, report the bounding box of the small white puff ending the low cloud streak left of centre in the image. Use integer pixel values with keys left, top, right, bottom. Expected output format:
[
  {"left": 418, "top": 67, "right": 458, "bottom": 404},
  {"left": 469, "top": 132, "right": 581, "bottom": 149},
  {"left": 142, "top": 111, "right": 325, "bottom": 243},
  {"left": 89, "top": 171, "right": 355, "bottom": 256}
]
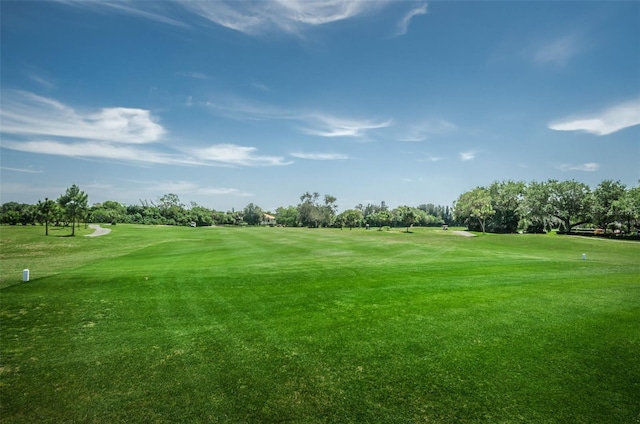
[{"left": 191, "top": 144, "right": 291, "bottom": 166}]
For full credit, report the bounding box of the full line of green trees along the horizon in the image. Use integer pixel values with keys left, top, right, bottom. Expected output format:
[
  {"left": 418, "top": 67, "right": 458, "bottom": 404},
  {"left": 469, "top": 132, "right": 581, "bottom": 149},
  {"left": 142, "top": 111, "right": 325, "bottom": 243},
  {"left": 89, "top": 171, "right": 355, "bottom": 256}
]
[{"left": 0, "top": 180, "right": 640, "bottom": 235}]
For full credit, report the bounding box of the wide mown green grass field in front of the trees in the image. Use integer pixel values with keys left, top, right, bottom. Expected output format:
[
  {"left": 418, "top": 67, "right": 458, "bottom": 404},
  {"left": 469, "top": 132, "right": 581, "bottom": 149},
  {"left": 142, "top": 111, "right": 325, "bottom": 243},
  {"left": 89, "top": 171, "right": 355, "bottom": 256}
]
[{"left": 0, "top": 225, "right": 640, "bottom": 423}]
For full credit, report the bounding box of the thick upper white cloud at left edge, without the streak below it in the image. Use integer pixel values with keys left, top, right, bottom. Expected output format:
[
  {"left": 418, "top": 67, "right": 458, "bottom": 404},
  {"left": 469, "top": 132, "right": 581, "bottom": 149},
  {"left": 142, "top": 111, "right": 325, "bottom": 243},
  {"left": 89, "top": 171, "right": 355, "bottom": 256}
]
[{"left": 0, "top": 90, "right": 166, "bottom": 144}]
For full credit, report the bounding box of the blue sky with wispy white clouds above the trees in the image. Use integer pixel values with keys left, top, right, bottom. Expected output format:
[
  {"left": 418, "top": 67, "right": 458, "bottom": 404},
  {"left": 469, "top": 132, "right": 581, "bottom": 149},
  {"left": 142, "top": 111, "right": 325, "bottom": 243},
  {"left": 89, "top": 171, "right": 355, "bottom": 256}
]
[{"left": 0, "top": 0, "right": 640, "bottom": 210}]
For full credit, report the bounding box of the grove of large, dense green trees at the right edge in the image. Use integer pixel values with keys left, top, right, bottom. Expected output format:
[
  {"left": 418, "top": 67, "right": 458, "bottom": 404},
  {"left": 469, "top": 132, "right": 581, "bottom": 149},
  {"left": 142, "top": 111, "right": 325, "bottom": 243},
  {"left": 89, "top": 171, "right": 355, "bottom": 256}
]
[{"left": 453, "top": 180, "right": 640, "bottom": 234}]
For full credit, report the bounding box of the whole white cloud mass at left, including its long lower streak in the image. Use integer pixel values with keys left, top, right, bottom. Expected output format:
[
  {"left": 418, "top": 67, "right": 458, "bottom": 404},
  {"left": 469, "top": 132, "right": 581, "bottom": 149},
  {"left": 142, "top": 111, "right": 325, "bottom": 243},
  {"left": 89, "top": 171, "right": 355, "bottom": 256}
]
[{"left": 0, "top": 91, "right": 290, "bottom": 166}]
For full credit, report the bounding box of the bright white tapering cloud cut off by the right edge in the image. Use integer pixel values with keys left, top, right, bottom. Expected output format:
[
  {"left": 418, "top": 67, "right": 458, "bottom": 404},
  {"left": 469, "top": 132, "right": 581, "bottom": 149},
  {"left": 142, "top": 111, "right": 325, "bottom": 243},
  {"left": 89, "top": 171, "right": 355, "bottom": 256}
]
[{"left": 549, "top": 99, "right": 640, "bottom": 135}]
